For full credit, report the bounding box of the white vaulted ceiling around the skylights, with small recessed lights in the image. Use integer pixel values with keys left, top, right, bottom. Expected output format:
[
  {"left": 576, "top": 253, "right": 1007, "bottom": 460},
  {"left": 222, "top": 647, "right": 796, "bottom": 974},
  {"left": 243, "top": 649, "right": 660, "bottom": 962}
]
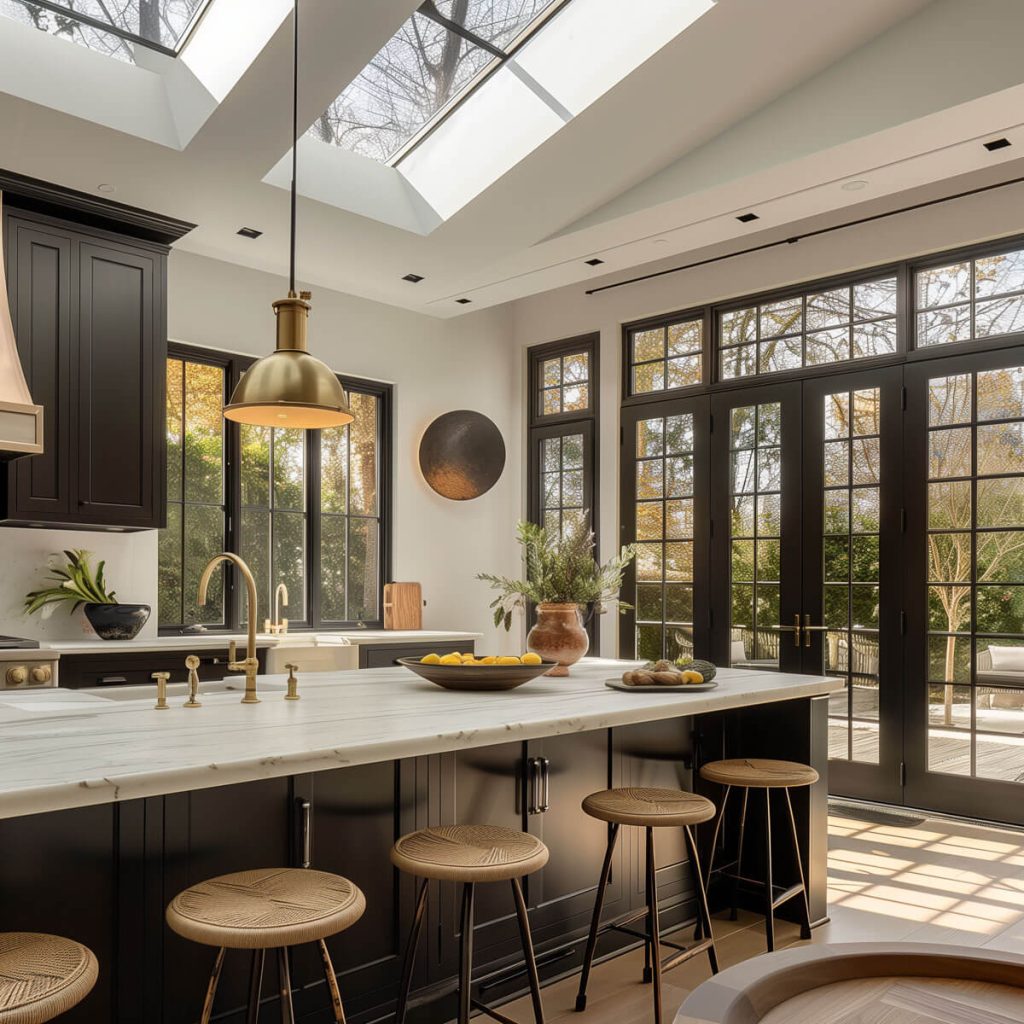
[{"left": 0, "top": 0, "right": 1024, "bottom": 316}]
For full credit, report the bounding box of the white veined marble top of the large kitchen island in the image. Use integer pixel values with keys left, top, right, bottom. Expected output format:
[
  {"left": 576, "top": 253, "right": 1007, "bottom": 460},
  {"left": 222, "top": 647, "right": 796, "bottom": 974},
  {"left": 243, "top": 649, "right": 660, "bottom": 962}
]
[{"left": 0, "top": 658, "right": 843, "bottom": 818}]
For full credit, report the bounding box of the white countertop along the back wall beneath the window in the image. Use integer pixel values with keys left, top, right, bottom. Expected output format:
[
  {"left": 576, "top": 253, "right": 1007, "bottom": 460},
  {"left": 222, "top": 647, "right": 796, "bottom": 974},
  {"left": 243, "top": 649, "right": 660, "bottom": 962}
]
[{"left": 41, "top": 630, "right": 482, "bottom": 654}]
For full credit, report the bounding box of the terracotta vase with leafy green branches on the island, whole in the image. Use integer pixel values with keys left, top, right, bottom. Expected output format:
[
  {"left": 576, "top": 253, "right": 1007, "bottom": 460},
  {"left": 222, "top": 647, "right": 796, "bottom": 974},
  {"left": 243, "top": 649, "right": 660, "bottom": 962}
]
[{"left": 477, "top": 513, "right": 636, "bottom": 676}]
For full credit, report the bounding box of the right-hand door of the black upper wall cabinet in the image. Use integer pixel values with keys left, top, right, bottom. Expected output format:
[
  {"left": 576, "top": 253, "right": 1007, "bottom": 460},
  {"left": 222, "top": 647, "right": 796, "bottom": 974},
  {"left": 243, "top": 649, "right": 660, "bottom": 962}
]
[{"left": 76, "top": 242, "right": 161, "bottom": 526}]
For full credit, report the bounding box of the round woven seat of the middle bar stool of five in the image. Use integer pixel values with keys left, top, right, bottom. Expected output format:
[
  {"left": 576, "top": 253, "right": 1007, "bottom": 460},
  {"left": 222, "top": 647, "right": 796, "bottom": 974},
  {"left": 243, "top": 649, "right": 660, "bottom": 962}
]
[{"left": 391, "top": 825, "right": 548, "bottom": 882}]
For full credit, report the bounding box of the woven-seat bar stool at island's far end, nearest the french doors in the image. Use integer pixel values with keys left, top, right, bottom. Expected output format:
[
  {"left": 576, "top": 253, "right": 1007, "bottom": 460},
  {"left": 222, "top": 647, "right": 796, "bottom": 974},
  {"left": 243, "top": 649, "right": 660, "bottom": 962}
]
[{"left": 700, "top": 758, "right": 818, "bottom": 952}]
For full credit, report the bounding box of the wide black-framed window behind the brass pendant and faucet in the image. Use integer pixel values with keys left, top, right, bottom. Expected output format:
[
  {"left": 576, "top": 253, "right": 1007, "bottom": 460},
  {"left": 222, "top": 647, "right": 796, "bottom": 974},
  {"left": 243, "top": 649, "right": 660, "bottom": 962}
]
[{"left": 160, "top": 346, "right": 391, "bottom": 632}]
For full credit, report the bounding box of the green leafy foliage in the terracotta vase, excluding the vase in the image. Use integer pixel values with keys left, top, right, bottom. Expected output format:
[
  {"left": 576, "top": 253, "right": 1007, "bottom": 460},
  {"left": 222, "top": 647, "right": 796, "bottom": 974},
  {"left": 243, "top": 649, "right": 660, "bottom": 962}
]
[{"left": 476, "top": 515, "right": 636, "bottom": 630}]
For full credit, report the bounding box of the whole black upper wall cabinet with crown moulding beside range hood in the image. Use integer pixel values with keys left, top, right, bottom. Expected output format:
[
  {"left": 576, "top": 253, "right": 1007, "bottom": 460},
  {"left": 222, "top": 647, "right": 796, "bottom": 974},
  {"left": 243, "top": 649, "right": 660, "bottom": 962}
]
[{"left": 0, "top": 172, "right": 190, "bottom": 529}]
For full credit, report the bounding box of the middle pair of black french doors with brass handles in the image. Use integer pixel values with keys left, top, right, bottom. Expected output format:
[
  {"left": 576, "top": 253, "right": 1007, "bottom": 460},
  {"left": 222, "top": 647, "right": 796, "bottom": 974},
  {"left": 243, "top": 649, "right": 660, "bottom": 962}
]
[{"left": 711, "top": 368, "right": 902, "bottom": 801}]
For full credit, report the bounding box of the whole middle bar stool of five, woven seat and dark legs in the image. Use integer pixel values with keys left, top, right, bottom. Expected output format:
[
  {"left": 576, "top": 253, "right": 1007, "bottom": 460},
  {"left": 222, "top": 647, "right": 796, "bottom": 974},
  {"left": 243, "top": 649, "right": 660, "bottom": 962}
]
[{"left": 391, "top": 825, "right": 548, "bottom": 1024}]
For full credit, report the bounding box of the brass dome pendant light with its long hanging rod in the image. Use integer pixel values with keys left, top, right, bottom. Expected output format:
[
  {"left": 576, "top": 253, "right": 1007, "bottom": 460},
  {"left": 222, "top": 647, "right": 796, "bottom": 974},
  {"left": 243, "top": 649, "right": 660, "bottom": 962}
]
[{"left": 224, "top": 0, "right": 353, "bottom": 430}]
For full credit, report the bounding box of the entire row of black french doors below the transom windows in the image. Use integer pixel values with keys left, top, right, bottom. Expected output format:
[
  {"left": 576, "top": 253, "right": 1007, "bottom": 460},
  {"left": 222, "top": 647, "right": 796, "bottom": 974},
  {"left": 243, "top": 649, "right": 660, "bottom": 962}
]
[{"left": 621, "top": 346, "right": 1024, "bottom": 824}]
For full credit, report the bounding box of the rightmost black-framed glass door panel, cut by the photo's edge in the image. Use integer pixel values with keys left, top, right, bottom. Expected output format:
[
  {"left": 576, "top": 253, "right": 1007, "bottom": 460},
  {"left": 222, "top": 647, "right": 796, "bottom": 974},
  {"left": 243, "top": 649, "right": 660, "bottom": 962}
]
[{"left": 903, "top": 346, "right": 1024, "bottom": 823}]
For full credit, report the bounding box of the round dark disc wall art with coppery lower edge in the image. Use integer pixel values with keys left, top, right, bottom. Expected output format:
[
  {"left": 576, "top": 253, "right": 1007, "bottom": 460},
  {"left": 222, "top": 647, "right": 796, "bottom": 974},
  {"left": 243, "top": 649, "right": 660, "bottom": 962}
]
[{"left": 420, "top": 409, "right": 505, "bottom": 502}]
